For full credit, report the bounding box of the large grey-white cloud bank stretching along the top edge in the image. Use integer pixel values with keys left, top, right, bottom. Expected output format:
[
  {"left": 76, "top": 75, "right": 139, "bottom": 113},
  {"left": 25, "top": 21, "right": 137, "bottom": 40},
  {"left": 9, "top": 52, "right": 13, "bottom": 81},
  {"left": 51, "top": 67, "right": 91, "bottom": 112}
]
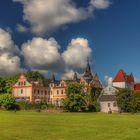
[{"left": 13, "top": 0, "right": 109, "bottom": 34}]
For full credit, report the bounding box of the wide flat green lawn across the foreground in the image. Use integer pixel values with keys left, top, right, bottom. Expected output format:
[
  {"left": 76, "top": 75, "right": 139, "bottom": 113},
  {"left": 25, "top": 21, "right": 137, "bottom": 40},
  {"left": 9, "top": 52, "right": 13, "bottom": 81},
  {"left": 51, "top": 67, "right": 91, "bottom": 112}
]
[{"left": 0, "top": 111, "right": 140, "bottom": 140}]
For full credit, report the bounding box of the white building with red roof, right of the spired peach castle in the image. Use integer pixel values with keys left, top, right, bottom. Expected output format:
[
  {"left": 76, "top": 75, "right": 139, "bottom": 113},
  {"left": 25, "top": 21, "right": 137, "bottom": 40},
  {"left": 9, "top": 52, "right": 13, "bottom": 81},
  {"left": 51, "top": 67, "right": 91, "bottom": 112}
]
[{"left": 98, "top": 69, "right": 140, "bottom": 112}]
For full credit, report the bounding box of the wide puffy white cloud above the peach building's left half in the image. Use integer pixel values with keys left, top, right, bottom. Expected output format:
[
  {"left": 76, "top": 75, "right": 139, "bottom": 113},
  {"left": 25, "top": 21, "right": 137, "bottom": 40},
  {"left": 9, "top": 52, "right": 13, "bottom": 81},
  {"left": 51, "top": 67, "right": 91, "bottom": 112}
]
[{"left": 22, "top": 38, "right": 63, "bottom": 71}]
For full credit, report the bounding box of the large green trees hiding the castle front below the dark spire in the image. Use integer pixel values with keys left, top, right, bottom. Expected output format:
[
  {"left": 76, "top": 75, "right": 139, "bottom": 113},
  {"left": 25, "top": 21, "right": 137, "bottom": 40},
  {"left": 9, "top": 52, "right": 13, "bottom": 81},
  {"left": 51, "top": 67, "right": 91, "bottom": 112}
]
[{"left": 64, "top": 83, "right": 100, "bottom": 112}]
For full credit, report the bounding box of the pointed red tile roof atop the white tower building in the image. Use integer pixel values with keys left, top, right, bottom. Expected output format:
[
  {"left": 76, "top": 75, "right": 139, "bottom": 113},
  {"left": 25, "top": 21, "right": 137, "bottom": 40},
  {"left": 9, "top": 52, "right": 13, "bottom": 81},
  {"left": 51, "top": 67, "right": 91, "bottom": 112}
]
[{"left": 113, "top": 69, "right": 134, "bottom": 83}]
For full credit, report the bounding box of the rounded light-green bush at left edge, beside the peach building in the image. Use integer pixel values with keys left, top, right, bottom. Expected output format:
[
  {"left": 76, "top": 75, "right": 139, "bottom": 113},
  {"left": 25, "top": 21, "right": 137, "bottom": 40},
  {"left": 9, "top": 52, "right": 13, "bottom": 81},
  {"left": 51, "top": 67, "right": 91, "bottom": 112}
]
[{"left": 0, "top": 94, "right": 15, "bottom": 110}]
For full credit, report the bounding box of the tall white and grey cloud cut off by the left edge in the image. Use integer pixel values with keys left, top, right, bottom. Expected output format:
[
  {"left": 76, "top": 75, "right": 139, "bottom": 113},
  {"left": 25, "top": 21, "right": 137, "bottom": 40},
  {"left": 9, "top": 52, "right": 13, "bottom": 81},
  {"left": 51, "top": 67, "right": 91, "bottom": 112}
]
[{"left": 0, "top": 28, "right": 21, "bottom": 75}]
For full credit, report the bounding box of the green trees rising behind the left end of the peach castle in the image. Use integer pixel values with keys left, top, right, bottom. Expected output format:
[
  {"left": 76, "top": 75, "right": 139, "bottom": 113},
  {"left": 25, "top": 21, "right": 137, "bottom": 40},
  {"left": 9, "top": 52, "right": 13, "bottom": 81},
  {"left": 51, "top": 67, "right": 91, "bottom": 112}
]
[{"left": 0, "top": 71, "right": 48, "bottom": 94}]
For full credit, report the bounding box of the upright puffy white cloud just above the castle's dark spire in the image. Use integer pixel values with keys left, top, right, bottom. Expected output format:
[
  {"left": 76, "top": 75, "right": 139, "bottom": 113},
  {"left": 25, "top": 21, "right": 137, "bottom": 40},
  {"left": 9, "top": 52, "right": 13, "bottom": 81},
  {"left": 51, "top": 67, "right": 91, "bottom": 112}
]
[{"left": 62, "top": 38, "right": 92, "bottom": 69}]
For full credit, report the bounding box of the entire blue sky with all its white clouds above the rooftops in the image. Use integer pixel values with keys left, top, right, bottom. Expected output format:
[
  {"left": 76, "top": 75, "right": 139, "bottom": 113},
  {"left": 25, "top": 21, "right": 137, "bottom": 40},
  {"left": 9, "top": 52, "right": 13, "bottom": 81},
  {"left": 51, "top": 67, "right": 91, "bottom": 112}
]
[{"left": 0, "top": 0, "right": 140, "bottom": 83}]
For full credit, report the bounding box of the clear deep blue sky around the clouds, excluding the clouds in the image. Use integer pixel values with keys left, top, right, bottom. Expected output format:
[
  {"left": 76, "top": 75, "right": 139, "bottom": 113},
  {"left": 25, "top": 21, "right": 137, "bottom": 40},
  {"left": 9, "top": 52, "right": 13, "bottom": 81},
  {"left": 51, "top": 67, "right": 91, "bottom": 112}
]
[{"left": 0, "top": 0, "right": 140, "bottom": 82}]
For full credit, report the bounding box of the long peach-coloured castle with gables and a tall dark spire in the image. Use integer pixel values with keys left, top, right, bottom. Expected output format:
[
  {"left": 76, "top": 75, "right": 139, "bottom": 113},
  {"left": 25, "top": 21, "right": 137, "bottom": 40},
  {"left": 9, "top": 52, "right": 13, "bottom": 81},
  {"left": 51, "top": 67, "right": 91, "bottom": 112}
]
[{"left": 12, "top": 60, "right": 102, "bottom": 106}]
